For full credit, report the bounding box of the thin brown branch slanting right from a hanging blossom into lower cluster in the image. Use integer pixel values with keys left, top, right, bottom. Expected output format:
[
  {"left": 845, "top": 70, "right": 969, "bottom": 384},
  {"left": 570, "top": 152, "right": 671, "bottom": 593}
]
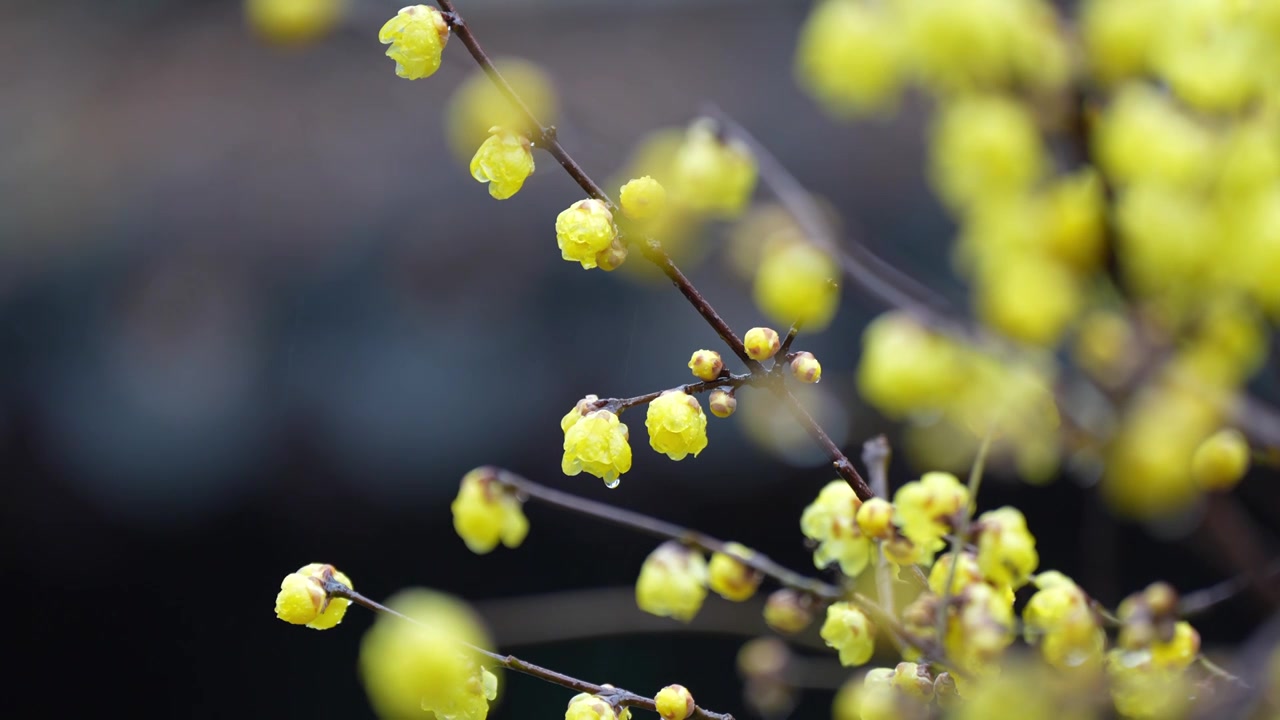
[{"left": 486, "top": 468, "right": 845, "bottom": 601}]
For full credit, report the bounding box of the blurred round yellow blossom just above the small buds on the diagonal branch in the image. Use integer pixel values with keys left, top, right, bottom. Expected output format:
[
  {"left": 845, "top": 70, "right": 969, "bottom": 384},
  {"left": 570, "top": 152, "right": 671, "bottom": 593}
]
[{"left": 753, "top": 240, "right": 840, "bottom": 332}]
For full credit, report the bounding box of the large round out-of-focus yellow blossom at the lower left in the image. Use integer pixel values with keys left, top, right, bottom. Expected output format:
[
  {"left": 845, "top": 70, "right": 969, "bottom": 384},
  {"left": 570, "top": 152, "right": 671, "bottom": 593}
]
[{"left": 360, "top": 588, "right": 498, "bottom": 720}]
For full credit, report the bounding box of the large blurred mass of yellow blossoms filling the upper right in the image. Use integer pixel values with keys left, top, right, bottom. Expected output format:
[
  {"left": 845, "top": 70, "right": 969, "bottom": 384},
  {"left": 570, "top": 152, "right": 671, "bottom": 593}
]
[{"left": 796, "top": 0, "right": 1280, "bottom": 516}]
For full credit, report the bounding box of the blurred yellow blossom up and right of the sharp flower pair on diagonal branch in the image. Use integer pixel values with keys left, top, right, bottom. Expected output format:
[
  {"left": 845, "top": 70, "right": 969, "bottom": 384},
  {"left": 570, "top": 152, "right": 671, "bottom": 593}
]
[{"left": 671, "top": 120, "right": 756, "bottom": 217}]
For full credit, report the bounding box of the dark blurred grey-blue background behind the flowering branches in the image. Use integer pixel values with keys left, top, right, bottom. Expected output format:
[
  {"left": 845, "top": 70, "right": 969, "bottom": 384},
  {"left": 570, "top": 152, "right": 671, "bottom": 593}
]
[{"left": 0, "top": 0, "right": 1280, "bottom": 719}]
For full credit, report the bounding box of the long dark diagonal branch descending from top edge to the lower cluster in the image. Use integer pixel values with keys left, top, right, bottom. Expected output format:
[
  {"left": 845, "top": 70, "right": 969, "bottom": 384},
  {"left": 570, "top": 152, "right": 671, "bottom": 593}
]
[{"left": 440, "top": 0, "right": 872, "bottom": 500}]
